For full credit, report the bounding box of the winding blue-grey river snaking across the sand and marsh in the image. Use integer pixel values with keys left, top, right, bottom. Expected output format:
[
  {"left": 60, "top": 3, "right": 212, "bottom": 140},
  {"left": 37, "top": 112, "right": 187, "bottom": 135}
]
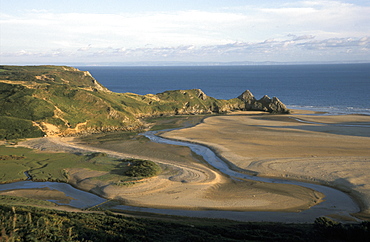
[{"left": 0, "top": 131, "right": 360, "bottom": 223}]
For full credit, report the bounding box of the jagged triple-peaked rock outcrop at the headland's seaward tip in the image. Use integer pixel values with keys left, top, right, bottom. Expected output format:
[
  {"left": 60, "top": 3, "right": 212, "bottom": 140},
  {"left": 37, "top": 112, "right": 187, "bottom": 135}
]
[{"left": 238, "top": 90, "right": 290, "bottom": 113}]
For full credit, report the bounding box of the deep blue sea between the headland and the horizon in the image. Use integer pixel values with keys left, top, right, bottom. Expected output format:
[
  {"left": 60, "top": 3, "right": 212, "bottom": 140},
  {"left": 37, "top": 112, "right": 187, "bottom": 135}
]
[{"left": 76, "top": 63, "right": 370, "bottom": 115}]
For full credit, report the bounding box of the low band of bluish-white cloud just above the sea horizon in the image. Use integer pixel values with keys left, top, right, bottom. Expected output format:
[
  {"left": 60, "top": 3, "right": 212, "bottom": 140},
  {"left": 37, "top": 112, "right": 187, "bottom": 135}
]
[{"left": 1, "top": 36, "right": 370, "bottom": 62}]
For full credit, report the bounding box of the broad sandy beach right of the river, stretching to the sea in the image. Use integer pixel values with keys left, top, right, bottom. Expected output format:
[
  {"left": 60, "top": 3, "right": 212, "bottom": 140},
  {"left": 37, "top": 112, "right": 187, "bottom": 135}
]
[{"left": 162, "top": 110, "right": 370, "bottom": 215}]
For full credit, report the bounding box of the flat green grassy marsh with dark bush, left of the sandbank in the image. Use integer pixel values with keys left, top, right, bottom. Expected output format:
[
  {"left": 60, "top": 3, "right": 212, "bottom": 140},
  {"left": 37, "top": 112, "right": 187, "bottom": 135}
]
[{"left": 0, "top": 146, "right": 161, "bottom": 185}]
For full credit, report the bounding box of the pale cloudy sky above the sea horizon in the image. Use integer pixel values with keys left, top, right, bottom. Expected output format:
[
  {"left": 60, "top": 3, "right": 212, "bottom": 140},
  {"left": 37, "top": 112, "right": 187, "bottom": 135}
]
[{"left": 0, "top": 0, "right": 370, "bottom": 65}]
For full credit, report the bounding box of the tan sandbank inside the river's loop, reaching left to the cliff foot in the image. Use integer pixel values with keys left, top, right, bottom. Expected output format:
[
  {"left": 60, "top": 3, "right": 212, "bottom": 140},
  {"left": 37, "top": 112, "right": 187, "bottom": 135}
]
[{"left": 14, "top": 117, "right": 323, "bottom": 216}]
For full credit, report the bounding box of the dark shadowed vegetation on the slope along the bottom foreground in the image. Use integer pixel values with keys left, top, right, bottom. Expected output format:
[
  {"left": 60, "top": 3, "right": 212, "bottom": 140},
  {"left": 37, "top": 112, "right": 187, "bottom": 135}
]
[{"left": 0, "top": 205, "right": 370, "bottom": 242}]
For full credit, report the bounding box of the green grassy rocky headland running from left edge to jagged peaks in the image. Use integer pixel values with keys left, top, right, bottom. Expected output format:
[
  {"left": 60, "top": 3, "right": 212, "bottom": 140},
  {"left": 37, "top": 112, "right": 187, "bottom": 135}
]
[{"left": 0, "top": 66, "right": 287, "bottom": 139}]
